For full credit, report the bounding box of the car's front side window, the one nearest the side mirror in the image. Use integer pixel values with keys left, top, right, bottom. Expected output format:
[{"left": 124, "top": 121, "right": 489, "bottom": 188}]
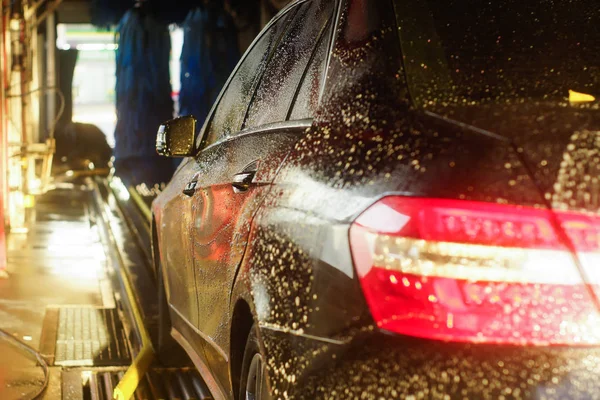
[{"left": 206, "top": 10, "right": 295, "bottom": 145}]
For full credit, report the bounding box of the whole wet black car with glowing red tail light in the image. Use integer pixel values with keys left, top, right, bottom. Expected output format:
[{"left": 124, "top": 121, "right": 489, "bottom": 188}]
[{"left": 153, "top": 0, "right": 600, "bottom": 400}]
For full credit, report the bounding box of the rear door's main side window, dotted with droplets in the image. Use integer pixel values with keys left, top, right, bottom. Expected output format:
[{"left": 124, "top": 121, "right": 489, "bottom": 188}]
[{"left": 245, "top": 0, "right": 333, "bottom": 128}]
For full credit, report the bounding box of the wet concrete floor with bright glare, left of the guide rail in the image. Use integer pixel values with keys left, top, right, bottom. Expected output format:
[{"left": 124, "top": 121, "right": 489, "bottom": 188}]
[{"left": 0, "top": 188, "right": 114, "bottom": 400}]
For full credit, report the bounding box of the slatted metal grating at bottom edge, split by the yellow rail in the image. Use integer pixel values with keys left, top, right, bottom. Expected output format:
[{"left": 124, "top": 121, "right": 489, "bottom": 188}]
[{"left": 83, "top": 369, "right": 212, "bottom": 400}]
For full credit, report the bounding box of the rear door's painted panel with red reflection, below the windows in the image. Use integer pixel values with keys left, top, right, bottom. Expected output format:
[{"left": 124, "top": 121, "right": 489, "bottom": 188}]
[{"left": 192, "top": 127, "right": 305, "bottom": 384}]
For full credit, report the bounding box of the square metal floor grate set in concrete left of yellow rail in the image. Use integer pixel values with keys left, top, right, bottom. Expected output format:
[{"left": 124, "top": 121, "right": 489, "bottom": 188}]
[{"left": 54, "top": 307, "right": 131, "bottom": 366}]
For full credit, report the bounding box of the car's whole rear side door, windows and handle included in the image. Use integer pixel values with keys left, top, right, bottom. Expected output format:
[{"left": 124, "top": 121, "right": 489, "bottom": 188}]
[{"left": 183, "top": 0, "right": 333, "bottom": 384}]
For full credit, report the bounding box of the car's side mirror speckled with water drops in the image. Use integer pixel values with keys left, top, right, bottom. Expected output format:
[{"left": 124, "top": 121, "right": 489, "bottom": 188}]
[{"left": 156, "top": 116, "right": 196, "bottom": 157}]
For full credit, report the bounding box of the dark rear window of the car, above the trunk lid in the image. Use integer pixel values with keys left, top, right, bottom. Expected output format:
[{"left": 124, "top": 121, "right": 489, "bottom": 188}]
[{"left": 395, "top": 0, "right": 600, "bottom": 103}]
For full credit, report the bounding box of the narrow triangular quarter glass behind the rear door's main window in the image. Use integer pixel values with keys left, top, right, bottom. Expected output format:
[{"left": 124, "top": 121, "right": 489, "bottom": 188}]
[{"left": 289, "top": 17, "right": 333, "bottom": 120}]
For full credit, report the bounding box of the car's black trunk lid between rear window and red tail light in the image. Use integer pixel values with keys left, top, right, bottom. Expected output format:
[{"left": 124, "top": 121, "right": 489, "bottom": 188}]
[{"left": 428, "top": 101, "right": 600, "bottom": 211}]
